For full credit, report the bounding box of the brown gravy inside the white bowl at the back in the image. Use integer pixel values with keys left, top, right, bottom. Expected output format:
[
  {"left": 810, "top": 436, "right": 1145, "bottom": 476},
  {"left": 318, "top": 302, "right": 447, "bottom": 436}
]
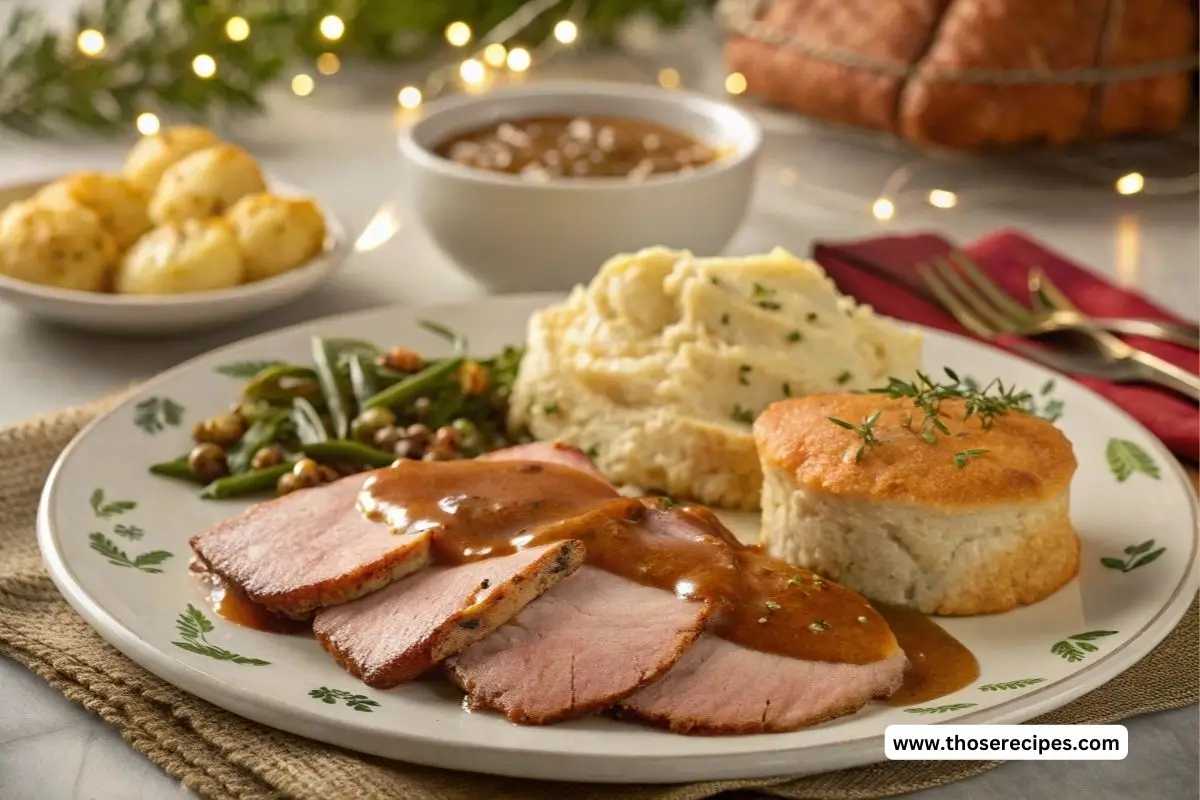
[{"left": 434, "top": 116, "right": 721, "bottom": 181}]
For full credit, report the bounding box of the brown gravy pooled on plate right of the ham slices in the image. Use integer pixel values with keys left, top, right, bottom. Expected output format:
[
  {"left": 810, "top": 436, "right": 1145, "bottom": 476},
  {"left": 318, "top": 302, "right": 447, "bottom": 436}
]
[{"left": 876, "top": 606, "right": 979, "bottom": 705}]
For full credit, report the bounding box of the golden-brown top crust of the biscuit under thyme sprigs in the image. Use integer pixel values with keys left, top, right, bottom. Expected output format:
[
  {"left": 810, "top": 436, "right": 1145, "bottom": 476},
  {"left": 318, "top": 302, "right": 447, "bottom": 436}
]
[{"left": 754, "top": 392, "right": 1075, "bottom": 509}]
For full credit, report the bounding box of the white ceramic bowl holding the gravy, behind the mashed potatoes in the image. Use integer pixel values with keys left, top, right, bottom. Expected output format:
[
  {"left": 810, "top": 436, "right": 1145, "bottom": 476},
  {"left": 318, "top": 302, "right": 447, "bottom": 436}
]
[{"left": 400, "top": 82, "right": 762, "bottom": 291}]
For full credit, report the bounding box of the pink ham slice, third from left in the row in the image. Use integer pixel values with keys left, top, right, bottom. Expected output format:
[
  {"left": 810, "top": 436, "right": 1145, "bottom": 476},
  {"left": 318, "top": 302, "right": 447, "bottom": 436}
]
[{"left": 446, "top": 565, "right": 708, "bottom": 724}]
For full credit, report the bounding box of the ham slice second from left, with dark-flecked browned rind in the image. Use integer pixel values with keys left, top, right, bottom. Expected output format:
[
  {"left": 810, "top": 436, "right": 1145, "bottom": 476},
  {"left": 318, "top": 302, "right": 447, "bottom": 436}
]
[{"left": 313, "top": 540, "right": 583, "bottom": 688}]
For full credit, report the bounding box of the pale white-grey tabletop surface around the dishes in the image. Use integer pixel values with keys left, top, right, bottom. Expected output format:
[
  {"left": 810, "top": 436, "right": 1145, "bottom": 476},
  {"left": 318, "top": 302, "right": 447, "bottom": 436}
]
[{"left": 0, "top": 20, "right": 1200, "bottom": 800}]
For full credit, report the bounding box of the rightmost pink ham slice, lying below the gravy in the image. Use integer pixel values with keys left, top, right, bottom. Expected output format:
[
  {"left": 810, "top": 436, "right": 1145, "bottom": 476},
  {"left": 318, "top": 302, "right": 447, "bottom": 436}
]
[{"left": 618, "top": 633, "right": 908, "bottom": 735}]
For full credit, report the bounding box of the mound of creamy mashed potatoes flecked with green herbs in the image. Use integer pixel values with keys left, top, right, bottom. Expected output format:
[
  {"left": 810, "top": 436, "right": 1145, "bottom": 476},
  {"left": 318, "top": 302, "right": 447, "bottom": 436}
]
[{"left": 510, "top": 248, "right": 920, "bottom": 509}]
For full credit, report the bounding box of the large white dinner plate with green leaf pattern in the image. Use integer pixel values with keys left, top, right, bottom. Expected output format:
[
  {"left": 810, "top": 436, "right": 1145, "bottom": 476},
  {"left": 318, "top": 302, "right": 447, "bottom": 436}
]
[{"left": 38, "top": 295, "right": 1196, "bottom": 782}]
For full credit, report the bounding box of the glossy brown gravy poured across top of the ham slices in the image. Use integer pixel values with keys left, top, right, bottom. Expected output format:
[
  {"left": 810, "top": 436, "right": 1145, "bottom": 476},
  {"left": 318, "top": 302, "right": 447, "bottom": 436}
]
[{"left": 359, "top": 458, "right": 899, "bottom": 664}]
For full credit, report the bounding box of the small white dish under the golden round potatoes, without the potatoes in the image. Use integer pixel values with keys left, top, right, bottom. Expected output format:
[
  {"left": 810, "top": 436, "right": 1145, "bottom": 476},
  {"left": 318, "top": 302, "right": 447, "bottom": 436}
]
[{"left": 0, "top": 176, "right": 349, "bottom": 336}]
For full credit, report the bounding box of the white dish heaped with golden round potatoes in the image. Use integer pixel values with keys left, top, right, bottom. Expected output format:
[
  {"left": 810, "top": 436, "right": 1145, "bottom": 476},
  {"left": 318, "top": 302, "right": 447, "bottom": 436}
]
[{"left": 0, "top": 126, "right": 348, "bottom": 336}]
